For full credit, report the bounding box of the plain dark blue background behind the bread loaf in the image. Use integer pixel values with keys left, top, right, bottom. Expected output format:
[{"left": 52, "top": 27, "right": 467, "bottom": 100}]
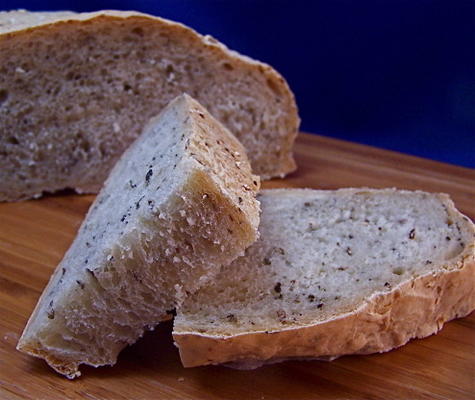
[{"left": 0, "top": 0, "right": 475, "bottom": 167}]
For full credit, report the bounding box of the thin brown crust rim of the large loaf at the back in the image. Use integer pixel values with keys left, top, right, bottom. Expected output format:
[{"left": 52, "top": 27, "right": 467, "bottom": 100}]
[{"left": 0, "top": 10, "right": 300, "bottom": 201}]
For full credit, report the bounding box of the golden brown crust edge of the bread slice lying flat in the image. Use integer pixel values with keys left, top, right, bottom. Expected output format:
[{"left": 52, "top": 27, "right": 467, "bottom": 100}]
[{"left": 173, "top": 244, "right": 475, "bottom": 367}]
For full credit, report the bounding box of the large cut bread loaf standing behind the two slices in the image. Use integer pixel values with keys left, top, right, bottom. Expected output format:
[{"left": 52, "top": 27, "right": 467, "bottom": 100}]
[{"left": 0, "top": 11, "right": 299, "bottom": 201}]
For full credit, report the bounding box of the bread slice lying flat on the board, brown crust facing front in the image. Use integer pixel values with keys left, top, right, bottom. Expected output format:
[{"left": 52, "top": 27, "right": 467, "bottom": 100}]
[{"left": 174, "top": 189, "right": 475, "bottom": 368}]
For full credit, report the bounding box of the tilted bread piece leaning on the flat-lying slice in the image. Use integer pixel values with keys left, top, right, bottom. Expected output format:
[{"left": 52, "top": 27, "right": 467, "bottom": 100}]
[{"left": 18, "top": 95, "right": 259, "bottom": 378}]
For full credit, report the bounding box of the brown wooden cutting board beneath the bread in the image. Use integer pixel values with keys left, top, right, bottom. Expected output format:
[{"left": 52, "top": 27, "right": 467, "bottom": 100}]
[{"left": 0, "top": 134, "right": 475, "bottom": 400}]
